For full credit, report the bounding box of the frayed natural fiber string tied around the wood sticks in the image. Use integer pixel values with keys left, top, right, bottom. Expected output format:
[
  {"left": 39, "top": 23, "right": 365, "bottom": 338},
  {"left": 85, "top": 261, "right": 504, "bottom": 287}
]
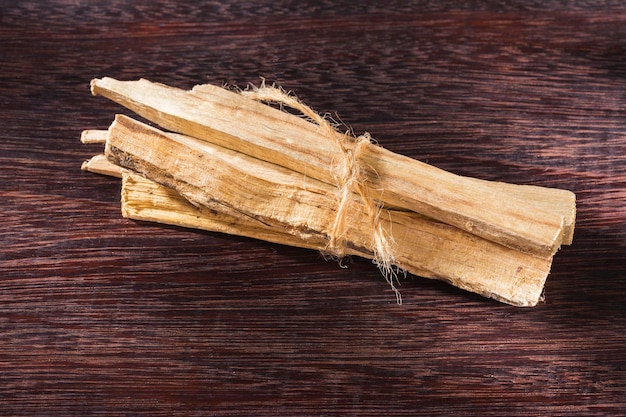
[{"left": 241, "top": 81, "right": 402, "bottom": 304}]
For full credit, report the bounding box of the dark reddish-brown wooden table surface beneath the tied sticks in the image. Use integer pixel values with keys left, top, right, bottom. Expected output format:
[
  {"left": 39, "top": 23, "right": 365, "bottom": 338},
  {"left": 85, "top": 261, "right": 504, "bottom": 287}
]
[{"left": 0, "top": 0, "right": 626, "bottom": 416}]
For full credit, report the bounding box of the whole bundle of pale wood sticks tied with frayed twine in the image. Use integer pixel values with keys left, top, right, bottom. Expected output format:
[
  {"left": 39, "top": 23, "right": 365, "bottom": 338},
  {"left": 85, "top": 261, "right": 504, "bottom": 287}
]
[{"left": 81, "top": 78, "right": 576, "bottom": 306}]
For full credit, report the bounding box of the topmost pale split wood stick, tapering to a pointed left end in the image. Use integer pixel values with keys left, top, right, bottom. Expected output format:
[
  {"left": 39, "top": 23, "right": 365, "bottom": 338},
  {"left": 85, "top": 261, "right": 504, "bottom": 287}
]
[{"left": 91, "top": 78, "right": 575, "bottom": 256}]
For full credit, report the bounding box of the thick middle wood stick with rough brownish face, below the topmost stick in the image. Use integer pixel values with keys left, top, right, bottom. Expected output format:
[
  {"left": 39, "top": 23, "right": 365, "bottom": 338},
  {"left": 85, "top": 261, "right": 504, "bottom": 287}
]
[{"left": 105, "top": 116, "right": 552, "bottom": 306}]
